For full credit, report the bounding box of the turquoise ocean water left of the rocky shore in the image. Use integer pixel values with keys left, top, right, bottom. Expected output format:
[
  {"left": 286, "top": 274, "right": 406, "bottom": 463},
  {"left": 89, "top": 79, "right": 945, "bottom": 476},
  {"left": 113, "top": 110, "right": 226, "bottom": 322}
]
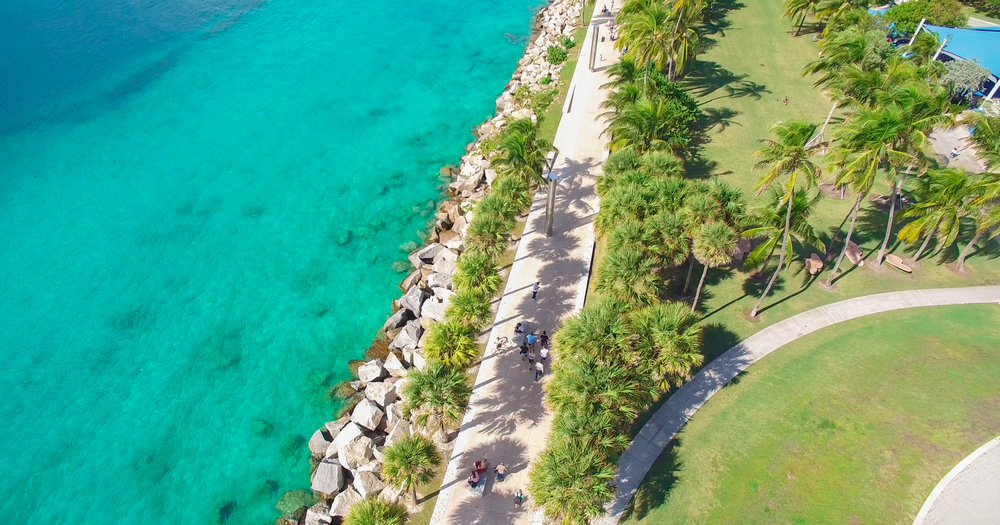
[{"left": 0, "top": 0, "right": 538, "bottom": 525}]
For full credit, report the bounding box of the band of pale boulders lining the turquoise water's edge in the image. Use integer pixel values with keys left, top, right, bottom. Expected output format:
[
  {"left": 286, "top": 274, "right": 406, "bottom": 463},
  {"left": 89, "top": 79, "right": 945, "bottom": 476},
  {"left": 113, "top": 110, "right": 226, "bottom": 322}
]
[{"left": 278, "top": 0, "right": 582, "bottom": 525}]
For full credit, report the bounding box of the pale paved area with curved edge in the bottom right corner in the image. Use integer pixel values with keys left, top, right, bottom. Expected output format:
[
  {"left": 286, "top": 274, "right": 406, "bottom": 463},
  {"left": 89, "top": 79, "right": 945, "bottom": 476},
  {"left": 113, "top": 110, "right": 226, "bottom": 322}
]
[{"left": 913, "top": 437, "right": 1000, "bottom": 525}]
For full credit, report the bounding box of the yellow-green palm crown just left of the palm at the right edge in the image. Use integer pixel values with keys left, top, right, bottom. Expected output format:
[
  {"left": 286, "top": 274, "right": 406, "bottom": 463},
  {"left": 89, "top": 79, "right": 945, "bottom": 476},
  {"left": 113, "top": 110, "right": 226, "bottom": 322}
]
[{"left": 899, "top": 168, "right": 976, "bottom": 261}]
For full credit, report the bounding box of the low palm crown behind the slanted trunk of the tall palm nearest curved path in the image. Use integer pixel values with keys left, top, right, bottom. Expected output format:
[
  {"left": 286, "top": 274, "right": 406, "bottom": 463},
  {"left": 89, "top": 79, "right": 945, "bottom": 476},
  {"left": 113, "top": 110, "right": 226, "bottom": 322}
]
[{"left": 740, "top": 190, "right": 826, "bottom": 274}]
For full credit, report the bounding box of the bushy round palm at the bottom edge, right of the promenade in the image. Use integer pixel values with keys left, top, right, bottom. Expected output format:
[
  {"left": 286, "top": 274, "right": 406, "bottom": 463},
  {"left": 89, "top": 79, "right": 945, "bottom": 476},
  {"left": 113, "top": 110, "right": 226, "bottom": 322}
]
[{"left": 528, "top": 440, "right": 615, "bottom": 525}]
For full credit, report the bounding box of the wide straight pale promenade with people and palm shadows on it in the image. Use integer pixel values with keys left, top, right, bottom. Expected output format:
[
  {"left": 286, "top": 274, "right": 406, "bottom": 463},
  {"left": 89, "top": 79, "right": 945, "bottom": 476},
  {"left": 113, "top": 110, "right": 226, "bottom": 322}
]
[{"left": 430, "top": 11, "right": 617, "bottom": 525}]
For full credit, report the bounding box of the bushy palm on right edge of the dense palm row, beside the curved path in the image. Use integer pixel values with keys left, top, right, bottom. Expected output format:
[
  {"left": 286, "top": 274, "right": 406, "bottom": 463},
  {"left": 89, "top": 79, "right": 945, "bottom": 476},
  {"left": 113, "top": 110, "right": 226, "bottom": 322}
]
[{"left": 632, "top": 303, "right": 705, "bottom": 390}]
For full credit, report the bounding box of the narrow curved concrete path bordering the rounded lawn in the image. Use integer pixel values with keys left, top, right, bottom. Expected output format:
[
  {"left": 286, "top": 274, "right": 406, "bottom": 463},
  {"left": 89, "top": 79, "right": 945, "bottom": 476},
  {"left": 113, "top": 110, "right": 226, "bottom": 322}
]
[{"left": 597, "top": 286, "right": 1000, "bottom": 525}]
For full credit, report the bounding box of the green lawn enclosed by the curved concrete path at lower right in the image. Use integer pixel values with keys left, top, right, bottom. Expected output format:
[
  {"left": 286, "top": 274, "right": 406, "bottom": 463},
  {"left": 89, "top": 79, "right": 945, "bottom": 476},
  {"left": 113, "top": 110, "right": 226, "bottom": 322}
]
[{"left": 623, "top": 305, "right": 1000, "bottom": 525}]
